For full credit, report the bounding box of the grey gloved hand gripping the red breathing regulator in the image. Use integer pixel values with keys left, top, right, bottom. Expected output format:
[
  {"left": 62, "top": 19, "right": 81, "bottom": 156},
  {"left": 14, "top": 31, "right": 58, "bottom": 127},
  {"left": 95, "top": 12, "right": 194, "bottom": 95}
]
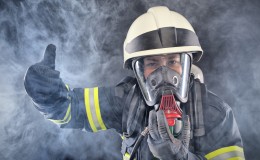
[{"left": 147, "top": 110, "right": 190, "bottom": 160}]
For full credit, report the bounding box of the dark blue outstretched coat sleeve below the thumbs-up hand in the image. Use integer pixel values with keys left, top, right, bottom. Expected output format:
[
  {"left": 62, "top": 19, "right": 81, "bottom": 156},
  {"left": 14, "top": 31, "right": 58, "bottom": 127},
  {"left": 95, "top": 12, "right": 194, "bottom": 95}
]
[{"left": 31, "top": 77, "right": 133, "bottom": 133}]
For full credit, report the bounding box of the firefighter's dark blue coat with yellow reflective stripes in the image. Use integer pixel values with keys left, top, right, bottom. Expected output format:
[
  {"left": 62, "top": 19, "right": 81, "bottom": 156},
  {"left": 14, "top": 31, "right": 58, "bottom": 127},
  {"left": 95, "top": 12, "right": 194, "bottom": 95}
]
[{"left": 32, "top": 77, "right": 244, "bottom": 160}]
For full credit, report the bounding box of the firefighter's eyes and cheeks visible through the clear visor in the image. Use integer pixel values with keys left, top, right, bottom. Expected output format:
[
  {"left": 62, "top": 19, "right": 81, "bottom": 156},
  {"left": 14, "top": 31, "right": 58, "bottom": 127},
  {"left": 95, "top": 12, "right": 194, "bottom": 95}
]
[{"left": 144, "top": 53, "right": 182, "bottom": 79}]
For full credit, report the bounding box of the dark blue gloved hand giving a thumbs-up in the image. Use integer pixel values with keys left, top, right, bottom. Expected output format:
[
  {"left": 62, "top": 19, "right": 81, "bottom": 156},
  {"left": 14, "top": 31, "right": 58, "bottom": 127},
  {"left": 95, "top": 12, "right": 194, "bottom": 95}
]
[{"left": 24, "top": 44, "right": 66, "bottom": 105}]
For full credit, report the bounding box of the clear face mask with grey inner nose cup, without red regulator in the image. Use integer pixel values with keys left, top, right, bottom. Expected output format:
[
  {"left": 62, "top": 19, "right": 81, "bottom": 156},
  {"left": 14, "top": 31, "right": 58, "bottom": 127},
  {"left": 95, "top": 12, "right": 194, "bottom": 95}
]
[{"left": 132, "top": 53, "right": 191, "bottom": 106}]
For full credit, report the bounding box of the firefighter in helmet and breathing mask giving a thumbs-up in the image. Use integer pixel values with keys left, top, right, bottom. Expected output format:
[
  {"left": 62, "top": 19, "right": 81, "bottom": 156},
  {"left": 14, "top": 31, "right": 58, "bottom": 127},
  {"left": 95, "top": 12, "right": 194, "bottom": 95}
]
[{"left": 24, "top": 6, "right": 244, "bottom": 160}]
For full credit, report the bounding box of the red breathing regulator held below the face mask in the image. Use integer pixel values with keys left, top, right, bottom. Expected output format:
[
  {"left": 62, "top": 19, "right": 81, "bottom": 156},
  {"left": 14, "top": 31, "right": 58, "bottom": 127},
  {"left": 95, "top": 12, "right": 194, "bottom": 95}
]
[{"left": 155, "top": 94, "right": 182, "bottom": 136}]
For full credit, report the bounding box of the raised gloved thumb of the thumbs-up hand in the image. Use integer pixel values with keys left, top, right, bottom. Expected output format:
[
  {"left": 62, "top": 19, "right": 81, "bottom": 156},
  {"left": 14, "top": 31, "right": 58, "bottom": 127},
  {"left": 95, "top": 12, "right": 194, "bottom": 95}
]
[{"left": 40, "top": 44, "right": 56, "bottom": 69}]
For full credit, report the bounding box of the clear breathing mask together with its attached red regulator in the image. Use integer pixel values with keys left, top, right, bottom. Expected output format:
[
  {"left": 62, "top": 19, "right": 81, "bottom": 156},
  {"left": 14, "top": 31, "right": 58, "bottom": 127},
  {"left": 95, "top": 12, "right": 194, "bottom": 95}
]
[{"left": 132, "top": 53, "right": 192, "bottom": 135}]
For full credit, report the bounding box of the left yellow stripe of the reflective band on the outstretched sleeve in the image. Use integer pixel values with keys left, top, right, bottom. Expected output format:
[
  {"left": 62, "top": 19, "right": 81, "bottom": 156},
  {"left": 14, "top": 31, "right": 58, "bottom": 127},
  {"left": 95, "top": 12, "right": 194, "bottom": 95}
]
[{"left": 84, "top": 88, "right": 97, "bottom": 132}]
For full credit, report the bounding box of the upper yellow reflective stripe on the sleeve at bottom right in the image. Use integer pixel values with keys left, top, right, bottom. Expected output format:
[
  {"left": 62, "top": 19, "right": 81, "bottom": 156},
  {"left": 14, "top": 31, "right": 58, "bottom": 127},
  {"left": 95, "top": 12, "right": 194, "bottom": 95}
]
[{"left": 205, "top": 146, "right": 244, "bottom": 159}]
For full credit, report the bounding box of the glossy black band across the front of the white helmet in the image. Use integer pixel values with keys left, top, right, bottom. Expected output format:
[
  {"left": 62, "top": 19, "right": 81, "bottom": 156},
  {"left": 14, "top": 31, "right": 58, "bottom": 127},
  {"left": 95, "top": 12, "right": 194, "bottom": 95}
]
[{"left": 125, "top": 27, "right": 200, "bottom": 53}]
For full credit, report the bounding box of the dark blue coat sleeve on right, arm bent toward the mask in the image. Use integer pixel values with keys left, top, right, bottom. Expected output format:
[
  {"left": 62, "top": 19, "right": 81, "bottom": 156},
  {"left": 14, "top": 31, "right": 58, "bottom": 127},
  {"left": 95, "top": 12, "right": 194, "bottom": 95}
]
[{"left": 193, "top": 92, "right": 245, "bottom": 160}]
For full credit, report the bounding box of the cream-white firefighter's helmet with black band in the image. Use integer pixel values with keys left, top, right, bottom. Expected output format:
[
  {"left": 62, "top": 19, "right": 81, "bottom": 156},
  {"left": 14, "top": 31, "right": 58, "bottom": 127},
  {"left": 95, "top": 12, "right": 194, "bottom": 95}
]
[{"left": 124, "top": 6, "right": 203, "bottom": 68}]
